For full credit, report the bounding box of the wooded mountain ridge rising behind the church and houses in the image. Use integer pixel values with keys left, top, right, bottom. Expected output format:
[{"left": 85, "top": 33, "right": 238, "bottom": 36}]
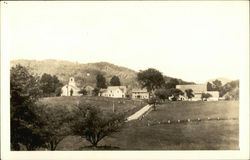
[{"left": 11, "top": 59, "right": 195, "bottom": 87}]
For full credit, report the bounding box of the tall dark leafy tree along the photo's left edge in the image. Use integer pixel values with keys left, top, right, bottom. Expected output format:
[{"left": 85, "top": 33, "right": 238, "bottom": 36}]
[{"left": 10, "top": 65, "right": 44, "bottom": 150}]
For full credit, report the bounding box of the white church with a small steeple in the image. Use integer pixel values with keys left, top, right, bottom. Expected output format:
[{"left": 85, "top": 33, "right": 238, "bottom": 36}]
[{"left": 61, "top": 77, "right": 80, "bottom": 96}]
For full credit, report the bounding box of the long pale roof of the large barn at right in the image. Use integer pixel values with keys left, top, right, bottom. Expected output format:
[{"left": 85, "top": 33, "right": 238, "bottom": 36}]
[{"left": 176, "top": 84, "right": 207, "bottom": 93}]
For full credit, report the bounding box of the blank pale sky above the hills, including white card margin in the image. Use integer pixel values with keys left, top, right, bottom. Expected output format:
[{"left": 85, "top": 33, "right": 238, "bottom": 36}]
[{"left": 1, "top": 1, "right": 249, "bottom": 83}]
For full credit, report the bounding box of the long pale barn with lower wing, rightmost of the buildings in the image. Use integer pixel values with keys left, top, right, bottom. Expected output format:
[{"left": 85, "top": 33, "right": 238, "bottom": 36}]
[{"left": 176, "top": 84, "right": 219, "bottom": 101}]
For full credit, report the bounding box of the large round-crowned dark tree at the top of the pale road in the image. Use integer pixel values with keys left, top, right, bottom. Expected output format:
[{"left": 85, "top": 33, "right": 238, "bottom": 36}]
[{"left": 137, "top": 68, "right": 165, "bottom": 93}]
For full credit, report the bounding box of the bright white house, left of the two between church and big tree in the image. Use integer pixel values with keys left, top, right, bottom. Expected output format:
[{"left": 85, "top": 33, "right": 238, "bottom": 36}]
[{"left": 99, "top": 86, "right": 127, "bottom": 98}]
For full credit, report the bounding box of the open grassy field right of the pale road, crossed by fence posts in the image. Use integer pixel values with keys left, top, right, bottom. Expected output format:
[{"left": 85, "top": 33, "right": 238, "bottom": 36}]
[{"left": 57, "top": 101, "right": 239, "bottom": 150}]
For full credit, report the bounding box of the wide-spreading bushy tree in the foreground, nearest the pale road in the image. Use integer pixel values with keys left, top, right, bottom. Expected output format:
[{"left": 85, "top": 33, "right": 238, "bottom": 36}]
[{"left": 72, "top": 102, "right": 124, "bottom": 148}]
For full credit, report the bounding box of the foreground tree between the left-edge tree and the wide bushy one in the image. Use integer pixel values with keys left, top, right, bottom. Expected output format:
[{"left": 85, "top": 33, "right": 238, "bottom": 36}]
[{"left": 36, "top": 105, "right": 73, "bottom": 151}]
